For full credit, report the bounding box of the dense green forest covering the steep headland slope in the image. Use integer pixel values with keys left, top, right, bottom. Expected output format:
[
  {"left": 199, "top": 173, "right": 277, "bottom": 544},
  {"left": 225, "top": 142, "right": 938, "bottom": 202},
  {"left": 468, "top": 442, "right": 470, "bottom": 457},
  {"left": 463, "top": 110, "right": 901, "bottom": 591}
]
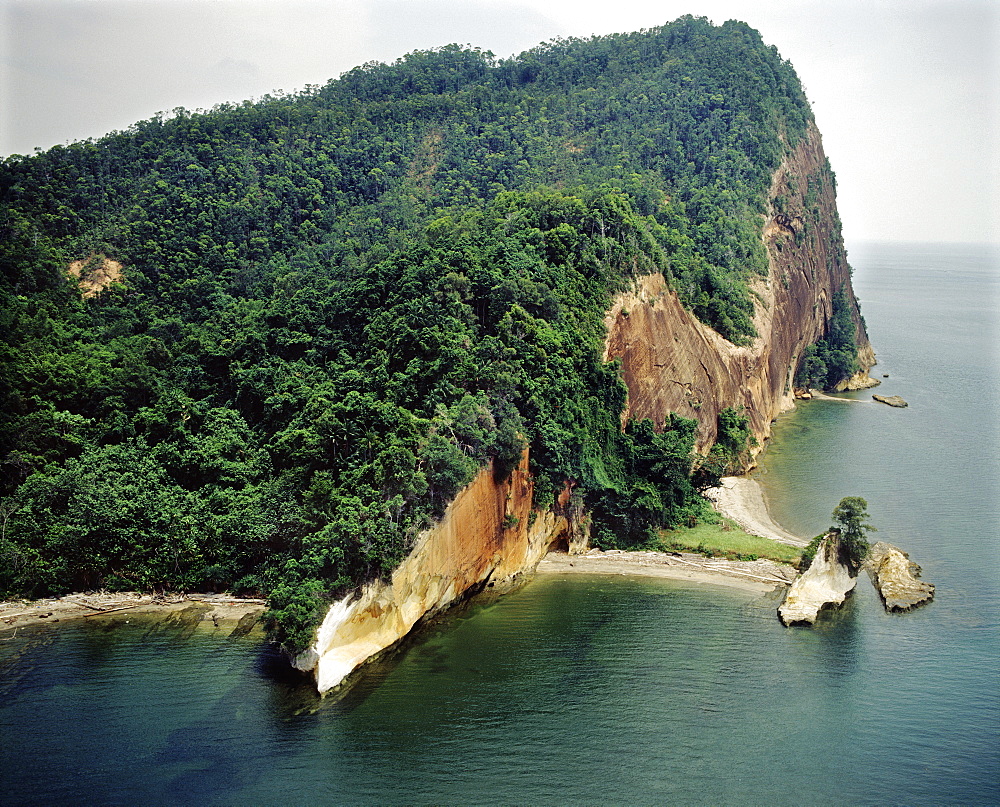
[{"left": 0, "top": 17, "right": 824, "bottom": 648}]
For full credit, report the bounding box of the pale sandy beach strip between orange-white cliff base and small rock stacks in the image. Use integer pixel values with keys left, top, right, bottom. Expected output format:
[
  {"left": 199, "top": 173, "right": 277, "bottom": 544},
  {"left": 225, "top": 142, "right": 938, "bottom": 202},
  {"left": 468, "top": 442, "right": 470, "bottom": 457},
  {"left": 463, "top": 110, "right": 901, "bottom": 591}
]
[{"left": 535, "top": 549, "right": 797, "bottom": 591}]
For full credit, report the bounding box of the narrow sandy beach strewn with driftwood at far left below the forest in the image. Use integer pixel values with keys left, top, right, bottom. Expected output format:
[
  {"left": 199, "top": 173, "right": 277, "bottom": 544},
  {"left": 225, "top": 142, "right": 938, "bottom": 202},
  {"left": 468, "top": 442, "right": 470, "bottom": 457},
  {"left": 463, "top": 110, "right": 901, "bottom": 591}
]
[{"left": 0, "top": 591, "right": 266, "bottom": 641}]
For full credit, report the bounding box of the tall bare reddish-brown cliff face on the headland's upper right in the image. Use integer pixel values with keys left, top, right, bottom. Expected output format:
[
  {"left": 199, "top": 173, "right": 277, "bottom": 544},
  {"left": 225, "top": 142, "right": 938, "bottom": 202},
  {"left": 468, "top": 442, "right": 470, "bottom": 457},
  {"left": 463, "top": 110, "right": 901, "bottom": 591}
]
[{"left": 605, "top": 125, "right": 875, "bottom": 450}]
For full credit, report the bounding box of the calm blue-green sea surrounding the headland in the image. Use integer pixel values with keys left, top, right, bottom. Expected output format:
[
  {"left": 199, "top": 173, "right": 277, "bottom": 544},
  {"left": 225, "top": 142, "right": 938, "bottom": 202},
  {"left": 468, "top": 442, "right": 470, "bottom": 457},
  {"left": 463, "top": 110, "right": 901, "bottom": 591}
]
[{"left": 0, "top": 243, "right": 1000, "bottom": 805}]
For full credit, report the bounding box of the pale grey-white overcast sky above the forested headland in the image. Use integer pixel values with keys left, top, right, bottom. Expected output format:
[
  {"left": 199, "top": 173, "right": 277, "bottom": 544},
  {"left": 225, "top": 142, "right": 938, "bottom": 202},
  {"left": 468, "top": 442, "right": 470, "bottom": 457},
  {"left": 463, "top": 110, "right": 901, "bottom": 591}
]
[{"left": 0, "top": 0, "right": 1000, "bottom": 246}]
